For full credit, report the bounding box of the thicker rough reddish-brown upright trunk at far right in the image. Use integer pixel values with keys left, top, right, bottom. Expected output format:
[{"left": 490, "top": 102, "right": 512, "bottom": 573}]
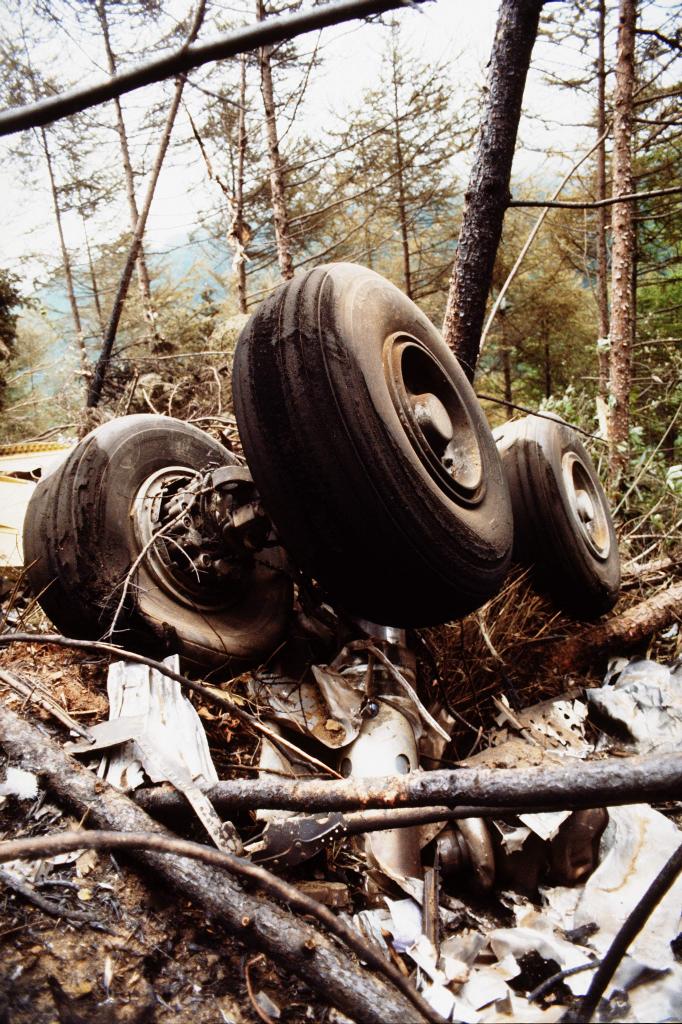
[{"left": 608, "top": 0, "right": 637, "bottom": 481}]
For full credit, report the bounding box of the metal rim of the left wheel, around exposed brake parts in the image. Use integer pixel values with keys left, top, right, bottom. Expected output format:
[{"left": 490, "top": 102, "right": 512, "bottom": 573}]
[{"left": 133, "top": 466, "right": 238, "bottom": 611}]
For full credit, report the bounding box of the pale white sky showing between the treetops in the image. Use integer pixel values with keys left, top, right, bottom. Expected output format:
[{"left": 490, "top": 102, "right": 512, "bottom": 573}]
[{"left": 0, "top": 0, "right": 630, "bottom": 287}]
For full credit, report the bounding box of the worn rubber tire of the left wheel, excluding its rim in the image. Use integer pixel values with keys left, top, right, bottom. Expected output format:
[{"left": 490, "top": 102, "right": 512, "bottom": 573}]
[{"left": 24, "top": 416, "right": 292, "bottom": 668}]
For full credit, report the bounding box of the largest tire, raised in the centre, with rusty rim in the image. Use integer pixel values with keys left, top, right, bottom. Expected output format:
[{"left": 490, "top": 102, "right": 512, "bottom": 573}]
[{"left": 233, "top": 263, "right": 512, "bottom": 627}]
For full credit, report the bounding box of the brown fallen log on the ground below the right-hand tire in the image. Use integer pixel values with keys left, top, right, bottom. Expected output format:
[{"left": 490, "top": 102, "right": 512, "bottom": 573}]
[{"left": 541, "top": 583, "right": 682, "bottom": 673}]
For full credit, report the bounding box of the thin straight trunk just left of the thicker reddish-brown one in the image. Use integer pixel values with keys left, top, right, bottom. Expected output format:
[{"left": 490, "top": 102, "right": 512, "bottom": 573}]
[{"left": 597, "top": 0, "right": 608, "bottom": 403}]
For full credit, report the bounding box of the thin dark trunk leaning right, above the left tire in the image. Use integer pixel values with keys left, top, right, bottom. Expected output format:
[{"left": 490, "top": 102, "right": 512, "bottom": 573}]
[{"left": 86, "top": 0, "right": 206, "bottom": 409}]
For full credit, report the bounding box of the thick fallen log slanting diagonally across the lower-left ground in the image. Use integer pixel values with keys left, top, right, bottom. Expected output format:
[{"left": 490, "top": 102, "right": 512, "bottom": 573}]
[{"left": 0, "top": 702, "right": 428, "bottom": 1024}]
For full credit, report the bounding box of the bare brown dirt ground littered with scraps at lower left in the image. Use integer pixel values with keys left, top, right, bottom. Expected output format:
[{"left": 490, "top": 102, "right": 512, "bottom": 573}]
[{"left": 0, "top": 645, "right": 328, "bottom": 1024}]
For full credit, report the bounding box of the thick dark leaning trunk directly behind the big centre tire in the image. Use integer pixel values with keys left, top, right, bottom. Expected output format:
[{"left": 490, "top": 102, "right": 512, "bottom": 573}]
[{"left": 442, "top": 0, "right": 543, "bottom": 380}]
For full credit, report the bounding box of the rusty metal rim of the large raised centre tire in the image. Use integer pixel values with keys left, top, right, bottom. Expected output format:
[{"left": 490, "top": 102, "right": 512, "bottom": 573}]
[{"left": 383, "top": 333, "right": 484, "bottom": 505}]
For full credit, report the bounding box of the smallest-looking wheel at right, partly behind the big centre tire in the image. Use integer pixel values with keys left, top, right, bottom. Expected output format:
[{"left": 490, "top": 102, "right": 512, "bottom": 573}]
[{"left": 495, "top": 416, "right": 621, "bottom": 620}]
